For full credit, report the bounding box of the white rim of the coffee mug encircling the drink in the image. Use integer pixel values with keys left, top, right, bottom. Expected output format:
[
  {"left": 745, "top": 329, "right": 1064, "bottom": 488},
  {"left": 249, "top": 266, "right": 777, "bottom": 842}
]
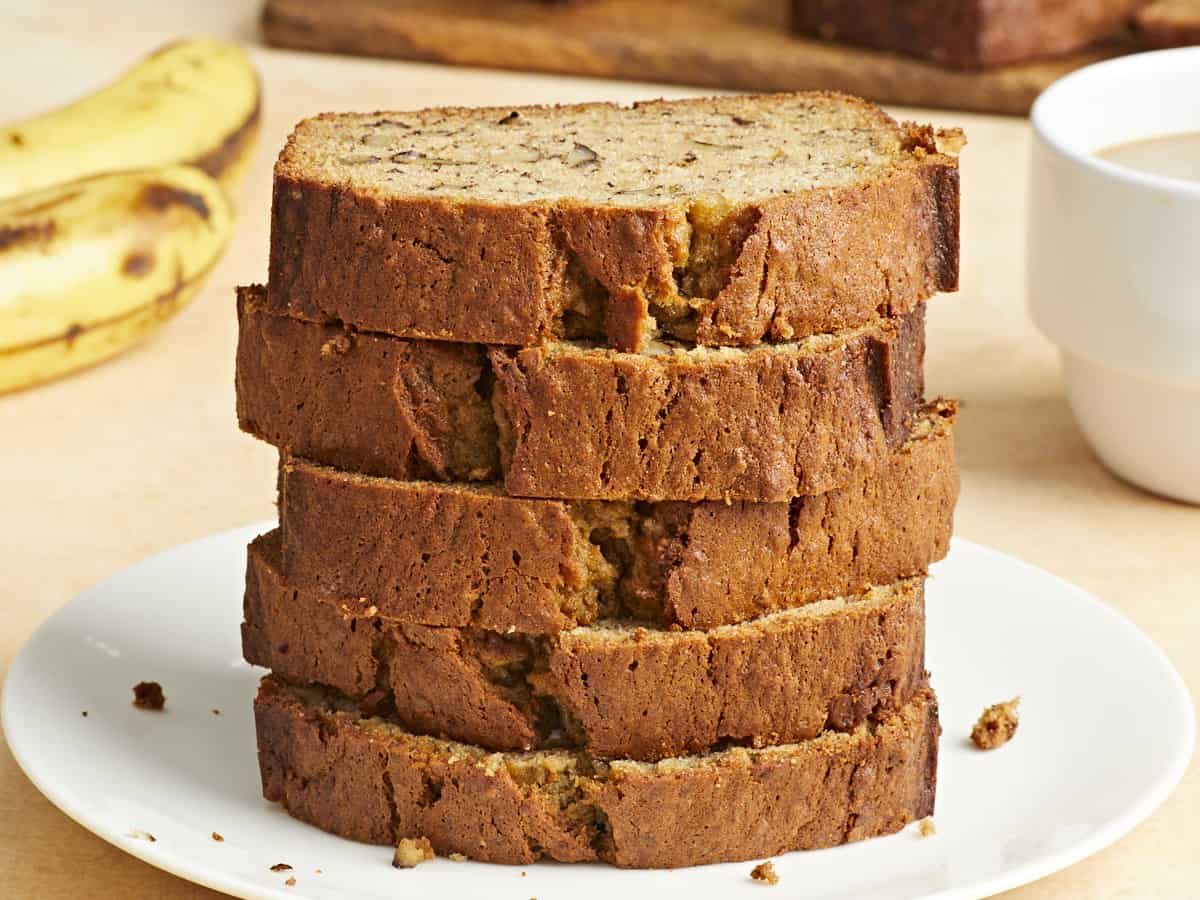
[{"left": 1030, "top": 46, "right": 1200, "bottom": 198}]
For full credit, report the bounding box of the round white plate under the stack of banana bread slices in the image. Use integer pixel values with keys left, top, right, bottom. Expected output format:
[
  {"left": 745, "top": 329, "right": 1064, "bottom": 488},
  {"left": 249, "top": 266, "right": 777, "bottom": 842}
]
[{"left": 2, "top": 523, "right": 1195, "bottom": 900}]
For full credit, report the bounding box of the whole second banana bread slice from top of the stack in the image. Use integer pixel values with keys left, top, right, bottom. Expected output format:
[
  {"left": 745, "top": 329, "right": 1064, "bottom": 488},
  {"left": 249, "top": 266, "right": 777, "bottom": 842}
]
[{"left": 236, "top": 289, "right": 925, "bottom": 500}]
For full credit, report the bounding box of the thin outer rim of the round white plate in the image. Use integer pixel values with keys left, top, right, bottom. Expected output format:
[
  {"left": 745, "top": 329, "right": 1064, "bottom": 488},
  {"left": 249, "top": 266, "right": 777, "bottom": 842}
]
[{"left": 0, "top": 528, "right": 1196, "bottom": 900}]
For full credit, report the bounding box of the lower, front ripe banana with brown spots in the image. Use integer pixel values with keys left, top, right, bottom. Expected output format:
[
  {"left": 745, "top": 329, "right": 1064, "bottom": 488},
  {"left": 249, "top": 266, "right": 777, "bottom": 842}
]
[{"left": 0, "top": 166, "right": 233, "bottom": 394}]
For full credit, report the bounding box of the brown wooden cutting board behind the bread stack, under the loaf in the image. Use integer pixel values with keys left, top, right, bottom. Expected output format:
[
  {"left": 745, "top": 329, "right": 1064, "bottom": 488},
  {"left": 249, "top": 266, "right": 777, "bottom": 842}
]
[{"left": 263, "top": 0, "right": 1134, "bottom": 115}]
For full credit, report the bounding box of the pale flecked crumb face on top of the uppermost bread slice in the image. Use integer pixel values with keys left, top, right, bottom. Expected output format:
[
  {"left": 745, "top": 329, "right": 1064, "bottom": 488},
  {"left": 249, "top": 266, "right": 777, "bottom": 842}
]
[{"left": 280, "top": 94, "right": 912, "bottom": 206}]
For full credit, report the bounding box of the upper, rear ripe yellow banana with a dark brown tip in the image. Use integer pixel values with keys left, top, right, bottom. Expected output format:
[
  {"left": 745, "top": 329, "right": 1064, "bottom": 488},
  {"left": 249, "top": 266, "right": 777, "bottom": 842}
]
[{"left": 0, "top": 40, "right": 259, "bottom": 197}]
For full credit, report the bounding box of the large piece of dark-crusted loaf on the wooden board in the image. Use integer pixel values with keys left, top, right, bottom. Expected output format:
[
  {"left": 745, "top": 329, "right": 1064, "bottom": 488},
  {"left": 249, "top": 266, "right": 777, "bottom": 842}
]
[{"left": 792, "top": 0, "right": 1146, "bottom": 68}]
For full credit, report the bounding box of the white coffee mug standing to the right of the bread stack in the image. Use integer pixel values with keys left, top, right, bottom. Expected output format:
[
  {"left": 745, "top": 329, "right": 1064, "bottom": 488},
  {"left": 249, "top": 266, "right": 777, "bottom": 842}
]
[{"left": 1026, "top": 47, "right": 1200, "bottom": 503}]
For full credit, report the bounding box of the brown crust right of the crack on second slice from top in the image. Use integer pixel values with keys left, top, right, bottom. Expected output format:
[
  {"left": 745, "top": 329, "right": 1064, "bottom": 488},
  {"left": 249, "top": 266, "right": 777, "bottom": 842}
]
[{"left": 490, "top": 307, "right": 925, "bottom": 500}]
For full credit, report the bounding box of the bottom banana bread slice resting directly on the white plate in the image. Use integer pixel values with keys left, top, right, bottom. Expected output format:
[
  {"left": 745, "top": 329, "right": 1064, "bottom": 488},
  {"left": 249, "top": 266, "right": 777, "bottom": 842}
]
[{"left": 254, "top": 676, "right": 941, "bottom": 869}]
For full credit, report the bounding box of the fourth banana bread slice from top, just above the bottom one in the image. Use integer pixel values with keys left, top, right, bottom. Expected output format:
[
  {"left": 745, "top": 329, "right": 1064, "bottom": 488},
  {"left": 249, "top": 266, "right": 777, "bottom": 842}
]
[{"left": 242, "top": 533, "right": 925, "bottom": 760}]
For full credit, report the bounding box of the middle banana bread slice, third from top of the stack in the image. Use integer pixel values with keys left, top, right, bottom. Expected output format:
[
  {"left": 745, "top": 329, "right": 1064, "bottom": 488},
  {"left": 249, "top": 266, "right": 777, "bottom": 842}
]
[{"left": 272, "top": 403, "right": 959, "bottom": 634}]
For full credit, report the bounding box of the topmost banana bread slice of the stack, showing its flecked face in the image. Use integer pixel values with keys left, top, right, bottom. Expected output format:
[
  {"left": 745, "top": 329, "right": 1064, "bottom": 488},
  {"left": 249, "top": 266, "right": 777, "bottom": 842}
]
[{"left": 269, "top": 94, "right": 961, "bottom": 350}]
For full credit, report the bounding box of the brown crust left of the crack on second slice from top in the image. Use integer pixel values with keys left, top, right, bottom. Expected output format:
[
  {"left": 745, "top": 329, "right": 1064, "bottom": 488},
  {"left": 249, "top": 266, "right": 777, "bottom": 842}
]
[{"left": 236, "top": 288, "right": 499, "bottom": 481}]
